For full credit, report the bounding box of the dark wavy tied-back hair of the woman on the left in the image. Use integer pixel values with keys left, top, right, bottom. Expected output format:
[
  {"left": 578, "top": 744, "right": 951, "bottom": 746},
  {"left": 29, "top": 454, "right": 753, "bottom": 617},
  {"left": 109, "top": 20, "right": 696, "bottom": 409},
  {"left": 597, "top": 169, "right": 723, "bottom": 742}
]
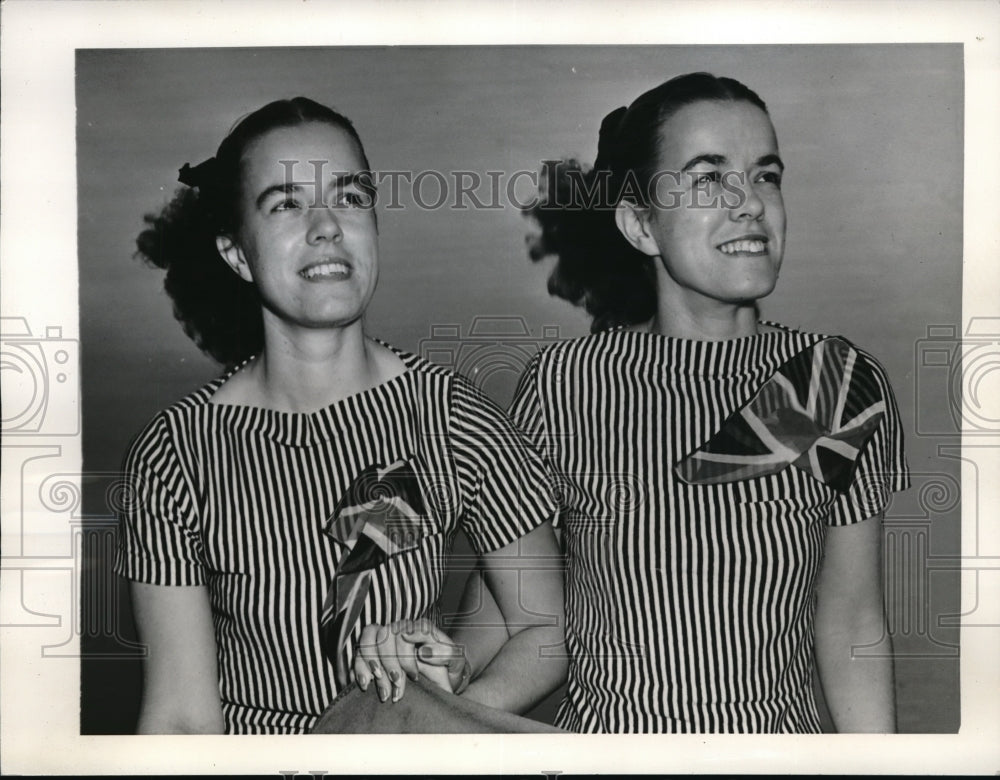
[{"left": 136, "top": 97, "right": 371, "bottom": 366}]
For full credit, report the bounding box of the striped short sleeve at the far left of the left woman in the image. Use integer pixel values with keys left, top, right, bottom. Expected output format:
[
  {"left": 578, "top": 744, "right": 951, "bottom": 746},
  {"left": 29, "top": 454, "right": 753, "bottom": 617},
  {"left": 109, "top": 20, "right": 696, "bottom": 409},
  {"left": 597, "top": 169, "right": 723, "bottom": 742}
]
[{"left": 115, "top": 415, "right": 206, "bottom": 585}]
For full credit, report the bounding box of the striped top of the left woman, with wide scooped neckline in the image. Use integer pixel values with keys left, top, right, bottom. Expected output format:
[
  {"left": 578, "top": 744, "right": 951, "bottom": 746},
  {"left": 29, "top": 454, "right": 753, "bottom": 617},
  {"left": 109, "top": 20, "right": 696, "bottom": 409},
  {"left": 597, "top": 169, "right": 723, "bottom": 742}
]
[{"left": 115, "top": 352, "right": 555, "bottom": 733}]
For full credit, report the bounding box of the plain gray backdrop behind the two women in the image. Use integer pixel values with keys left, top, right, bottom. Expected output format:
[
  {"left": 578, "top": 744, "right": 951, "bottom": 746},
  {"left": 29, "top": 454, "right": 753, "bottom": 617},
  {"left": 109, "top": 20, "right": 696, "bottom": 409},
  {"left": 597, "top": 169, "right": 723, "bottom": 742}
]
[{"left": 76, "top": 44, "right": 963, "bottom": 733}]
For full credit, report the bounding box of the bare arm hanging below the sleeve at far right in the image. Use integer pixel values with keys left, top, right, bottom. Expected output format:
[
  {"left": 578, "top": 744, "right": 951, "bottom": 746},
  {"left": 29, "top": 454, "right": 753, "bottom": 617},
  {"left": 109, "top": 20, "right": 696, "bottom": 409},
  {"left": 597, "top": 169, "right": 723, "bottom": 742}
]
[{"left": 816, "top": 516, "right": 896, "bottom": 734}]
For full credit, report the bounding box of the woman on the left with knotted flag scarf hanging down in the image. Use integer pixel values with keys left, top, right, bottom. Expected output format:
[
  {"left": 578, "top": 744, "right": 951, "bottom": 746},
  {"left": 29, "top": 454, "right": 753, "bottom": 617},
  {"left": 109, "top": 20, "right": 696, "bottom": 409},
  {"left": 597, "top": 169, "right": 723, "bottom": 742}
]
[{"left": 116, "top": 98, "right": 565, "bottom": 733}]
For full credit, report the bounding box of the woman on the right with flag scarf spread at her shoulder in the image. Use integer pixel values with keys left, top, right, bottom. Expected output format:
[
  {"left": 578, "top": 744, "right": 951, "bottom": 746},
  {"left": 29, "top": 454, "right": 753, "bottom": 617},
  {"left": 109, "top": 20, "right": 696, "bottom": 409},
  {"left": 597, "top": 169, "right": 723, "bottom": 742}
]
[{"left": 386, "top": 73, "right": 908, "bottom": 733}]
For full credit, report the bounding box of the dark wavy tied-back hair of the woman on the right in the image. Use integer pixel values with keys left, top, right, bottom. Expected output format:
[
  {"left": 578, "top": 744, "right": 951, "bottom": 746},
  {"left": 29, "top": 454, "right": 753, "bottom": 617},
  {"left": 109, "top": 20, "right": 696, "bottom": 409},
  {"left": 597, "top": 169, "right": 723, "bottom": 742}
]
[{"left": 526, "top": 73, "right": 767, "bottom": 333}]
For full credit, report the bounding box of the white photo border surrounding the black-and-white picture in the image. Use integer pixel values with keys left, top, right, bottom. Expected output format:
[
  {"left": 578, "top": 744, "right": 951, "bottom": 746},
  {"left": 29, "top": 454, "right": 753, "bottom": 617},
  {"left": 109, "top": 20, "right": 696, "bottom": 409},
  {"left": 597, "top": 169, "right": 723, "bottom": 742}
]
[{"left": 0, "top": 0, "right": 1000, "bottom": 775}]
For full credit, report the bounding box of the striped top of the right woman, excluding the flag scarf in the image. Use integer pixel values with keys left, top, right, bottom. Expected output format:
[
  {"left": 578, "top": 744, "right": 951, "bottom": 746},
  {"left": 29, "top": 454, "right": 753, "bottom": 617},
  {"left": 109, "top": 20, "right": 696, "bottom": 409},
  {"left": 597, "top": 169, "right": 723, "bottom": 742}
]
[{"left": 510, "top": 326, "right": 908, "bottom": 733}]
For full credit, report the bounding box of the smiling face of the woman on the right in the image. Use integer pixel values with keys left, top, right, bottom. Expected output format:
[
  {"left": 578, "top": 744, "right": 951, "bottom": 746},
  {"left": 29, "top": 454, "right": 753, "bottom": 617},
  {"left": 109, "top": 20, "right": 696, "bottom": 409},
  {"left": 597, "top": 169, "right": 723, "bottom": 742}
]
[{"left": 636, "top": 101, "right": 785, "bottom": 310}]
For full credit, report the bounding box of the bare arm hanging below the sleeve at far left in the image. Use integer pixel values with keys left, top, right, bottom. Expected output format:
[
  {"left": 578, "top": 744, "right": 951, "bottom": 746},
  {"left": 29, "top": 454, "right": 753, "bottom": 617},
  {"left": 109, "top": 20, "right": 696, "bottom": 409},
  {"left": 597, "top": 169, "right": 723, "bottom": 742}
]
[{"left": 132, "top": 582, "right": 224, "bottom": 734}]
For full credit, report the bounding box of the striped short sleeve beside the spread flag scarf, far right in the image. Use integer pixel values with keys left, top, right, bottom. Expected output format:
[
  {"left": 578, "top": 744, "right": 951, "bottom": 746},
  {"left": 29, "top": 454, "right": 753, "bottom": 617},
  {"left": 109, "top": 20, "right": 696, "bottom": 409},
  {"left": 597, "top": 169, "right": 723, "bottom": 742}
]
[{"left": 827, "top": 348, "right": 910, "bottom": 526}]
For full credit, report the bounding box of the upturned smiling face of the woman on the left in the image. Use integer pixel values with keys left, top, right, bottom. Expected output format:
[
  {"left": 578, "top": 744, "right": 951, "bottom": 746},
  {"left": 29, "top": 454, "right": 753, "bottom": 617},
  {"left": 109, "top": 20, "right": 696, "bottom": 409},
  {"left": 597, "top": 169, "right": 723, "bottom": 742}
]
[{"left": 220, "top": 122, "right": 378, "bottom": 329}]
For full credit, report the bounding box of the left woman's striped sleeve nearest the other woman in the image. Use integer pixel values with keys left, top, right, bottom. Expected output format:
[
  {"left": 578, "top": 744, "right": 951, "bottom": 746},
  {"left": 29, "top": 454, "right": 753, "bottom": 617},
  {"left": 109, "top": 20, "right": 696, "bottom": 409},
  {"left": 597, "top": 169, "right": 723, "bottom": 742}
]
[{"left": 451, "top": 376, "right": 556, "bottom": 555}]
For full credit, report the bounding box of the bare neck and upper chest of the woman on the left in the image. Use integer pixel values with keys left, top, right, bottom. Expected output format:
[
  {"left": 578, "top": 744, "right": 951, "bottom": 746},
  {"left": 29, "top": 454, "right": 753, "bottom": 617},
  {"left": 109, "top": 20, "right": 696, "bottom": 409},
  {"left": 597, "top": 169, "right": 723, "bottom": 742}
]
[{"left": 217, "top": 320, "right": 406, "bottom": 412}]
